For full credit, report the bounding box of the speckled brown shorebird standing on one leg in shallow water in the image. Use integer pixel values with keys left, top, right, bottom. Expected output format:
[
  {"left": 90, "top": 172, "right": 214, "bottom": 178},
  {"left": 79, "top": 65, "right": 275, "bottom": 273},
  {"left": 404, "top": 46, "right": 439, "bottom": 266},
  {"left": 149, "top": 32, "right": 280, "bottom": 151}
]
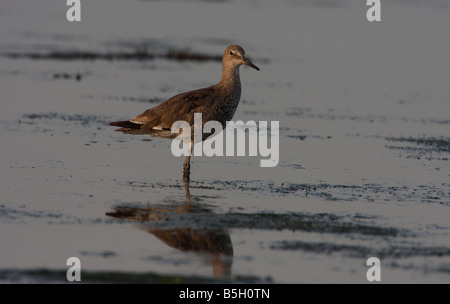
[{"left": 110, "top": 45, "right": 259, "bottom": 181}]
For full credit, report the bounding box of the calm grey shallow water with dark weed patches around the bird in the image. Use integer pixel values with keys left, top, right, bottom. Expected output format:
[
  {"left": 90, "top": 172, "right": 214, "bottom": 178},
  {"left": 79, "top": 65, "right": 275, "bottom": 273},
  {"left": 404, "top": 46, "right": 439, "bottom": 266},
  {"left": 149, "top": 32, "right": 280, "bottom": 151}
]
[{"left": 0, "top": 0, "right": 450, "bottom": 283}]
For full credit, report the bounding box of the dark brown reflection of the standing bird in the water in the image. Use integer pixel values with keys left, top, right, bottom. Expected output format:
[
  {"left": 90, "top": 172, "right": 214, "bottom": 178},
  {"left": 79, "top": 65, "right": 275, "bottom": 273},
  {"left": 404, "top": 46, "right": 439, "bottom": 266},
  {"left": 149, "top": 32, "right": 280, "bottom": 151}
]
[{"left": 106, "top": 180, "right": 233, "bottom": 277}]
